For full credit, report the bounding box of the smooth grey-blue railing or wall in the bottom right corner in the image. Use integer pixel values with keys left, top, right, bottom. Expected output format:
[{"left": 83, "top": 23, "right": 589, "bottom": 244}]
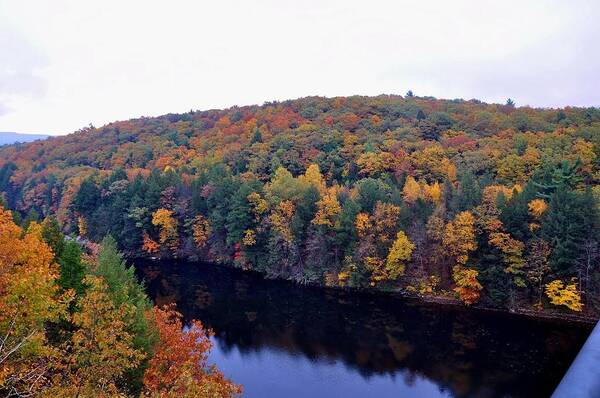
[{"left": 552, "top": 322, "right": 600, "bottom": 398}]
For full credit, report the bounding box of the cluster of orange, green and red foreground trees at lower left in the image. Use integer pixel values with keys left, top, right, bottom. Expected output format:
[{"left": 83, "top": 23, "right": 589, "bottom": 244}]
[{"left": 0, "top": 207, "right": 241, "bottom": 398}]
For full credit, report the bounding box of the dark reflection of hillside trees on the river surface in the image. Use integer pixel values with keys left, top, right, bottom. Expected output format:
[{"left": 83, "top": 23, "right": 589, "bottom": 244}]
[{"left": 140, "top": 263, "right": 590, "bottom": 397}]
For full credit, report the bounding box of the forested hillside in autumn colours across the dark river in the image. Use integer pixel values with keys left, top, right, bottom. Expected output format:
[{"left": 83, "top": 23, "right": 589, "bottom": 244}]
[{"left": 0, "top": 95, "right": 600, "bottom": 316}]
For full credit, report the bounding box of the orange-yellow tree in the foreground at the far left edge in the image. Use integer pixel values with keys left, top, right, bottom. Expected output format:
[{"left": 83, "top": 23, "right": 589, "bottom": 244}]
[{"left": 0, "top": 206, "right": 69, "bottom": 396}]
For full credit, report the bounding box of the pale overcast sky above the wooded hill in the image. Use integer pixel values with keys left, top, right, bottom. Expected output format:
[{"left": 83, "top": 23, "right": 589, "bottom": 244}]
[{"left": 0, "top": 0, "right": 600, "bottom": 134}]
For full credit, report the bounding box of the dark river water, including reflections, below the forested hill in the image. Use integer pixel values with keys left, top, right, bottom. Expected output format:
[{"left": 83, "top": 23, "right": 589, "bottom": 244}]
[{"left": 136, "top": 262, "right": 592, "bottom": 398}]
